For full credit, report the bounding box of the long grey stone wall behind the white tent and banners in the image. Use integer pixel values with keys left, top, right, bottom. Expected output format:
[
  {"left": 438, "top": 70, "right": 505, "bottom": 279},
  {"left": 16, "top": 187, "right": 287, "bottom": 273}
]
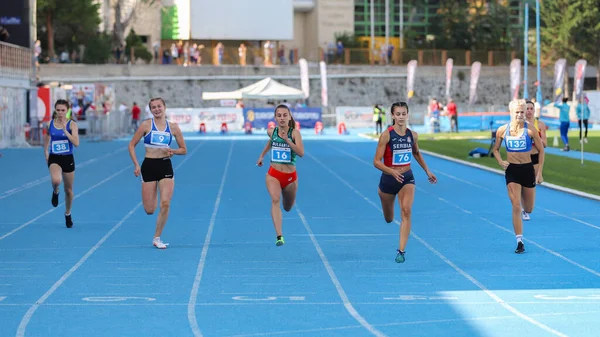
[{"left": 41, "top": 64, "right": 568, "bottom": 120}]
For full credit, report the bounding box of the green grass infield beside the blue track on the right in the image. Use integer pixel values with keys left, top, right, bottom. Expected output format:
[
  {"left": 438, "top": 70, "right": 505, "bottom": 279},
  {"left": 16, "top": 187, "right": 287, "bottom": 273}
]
[{"left": 366, "top": 131, "right": 600, "bottom": 195}]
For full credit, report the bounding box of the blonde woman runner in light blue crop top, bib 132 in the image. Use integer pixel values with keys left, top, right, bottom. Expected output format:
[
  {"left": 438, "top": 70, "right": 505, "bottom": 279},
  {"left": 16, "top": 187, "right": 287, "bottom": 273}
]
[{"left": 494, "top": 99, "right": 544, "bottom": 254}]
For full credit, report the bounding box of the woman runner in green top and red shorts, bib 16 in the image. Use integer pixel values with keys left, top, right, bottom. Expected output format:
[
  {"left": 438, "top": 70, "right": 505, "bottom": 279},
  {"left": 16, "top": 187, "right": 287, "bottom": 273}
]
[{"left": 256, "top": 104, "right": 304, "bottom": 246}]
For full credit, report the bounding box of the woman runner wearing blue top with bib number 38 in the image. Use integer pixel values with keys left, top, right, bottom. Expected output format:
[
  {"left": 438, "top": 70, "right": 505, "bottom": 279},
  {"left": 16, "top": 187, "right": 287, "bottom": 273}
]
[{"left": 44, "top": 99, "right": 79, "bottom": 228}]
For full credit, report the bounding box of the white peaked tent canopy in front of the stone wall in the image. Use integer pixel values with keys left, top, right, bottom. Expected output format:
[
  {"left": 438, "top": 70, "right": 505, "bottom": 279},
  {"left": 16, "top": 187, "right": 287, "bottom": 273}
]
[{"left": 202, "top": 77, "right": 304, "bottom": 100}]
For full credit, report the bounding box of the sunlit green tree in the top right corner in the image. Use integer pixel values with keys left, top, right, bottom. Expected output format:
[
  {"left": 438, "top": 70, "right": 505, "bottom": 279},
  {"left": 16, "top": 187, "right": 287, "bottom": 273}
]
[{"left": 533, "top": 0, "right": 600, "bottom": 90}]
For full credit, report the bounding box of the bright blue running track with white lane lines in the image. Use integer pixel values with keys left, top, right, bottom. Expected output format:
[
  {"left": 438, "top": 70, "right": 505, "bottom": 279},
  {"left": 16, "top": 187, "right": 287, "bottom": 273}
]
[{"left": 0, "top": 134, "right": 600, "bottom": 337}]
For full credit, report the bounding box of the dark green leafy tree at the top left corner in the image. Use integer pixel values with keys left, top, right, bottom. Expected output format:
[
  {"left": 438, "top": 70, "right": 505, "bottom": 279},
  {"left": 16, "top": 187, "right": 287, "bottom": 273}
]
[{"left": 37, "top": 0, "right": 100, "bottom": 58}]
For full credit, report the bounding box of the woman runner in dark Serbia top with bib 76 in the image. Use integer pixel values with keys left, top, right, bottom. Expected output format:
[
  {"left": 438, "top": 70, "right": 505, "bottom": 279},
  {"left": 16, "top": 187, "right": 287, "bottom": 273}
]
[{"left": 373, "top": 102, "right": 437, "bottom": 263}]
